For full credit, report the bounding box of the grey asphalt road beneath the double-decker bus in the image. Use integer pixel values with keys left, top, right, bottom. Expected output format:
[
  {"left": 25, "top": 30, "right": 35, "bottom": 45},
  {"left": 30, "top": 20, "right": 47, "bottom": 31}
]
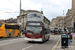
[{"left": 0, "top": 36, "right": 59, "bottom": 50}]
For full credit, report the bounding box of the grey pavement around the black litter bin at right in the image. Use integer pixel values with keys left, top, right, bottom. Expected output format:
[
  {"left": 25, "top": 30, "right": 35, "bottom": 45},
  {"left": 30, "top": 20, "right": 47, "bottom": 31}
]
[{"left": 55, "top": 36, "right": 75, "bottom": 50}]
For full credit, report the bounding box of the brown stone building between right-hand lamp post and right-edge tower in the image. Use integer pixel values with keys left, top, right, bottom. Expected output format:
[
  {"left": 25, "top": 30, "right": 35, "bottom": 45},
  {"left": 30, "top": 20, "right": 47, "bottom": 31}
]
[{"left": 65, "top": 9, "right": 72, "bottom": 29}]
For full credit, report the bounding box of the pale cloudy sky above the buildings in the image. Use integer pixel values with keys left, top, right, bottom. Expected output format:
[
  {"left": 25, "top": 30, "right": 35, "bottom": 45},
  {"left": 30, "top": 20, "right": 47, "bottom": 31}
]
[{"left": 0, "top": 0, "right": 72, "bottom": 20}]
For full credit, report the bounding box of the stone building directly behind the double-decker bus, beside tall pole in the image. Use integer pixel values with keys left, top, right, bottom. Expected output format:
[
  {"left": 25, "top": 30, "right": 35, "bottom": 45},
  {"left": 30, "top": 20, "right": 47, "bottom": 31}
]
[{"left": 17, "top": 10, "right": 43, "bottom": 28}]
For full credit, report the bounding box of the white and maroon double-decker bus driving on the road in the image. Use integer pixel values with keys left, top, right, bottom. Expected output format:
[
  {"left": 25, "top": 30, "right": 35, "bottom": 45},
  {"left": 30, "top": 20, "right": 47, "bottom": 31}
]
[{"left": 25, "top": 13, "right": 50, "bottom": 42}]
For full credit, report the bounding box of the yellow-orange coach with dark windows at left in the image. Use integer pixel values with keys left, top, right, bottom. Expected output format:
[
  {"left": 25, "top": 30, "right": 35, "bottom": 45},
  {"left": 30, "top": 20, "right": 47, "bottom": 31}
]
[{"left": 0, "top": 23, "right": 21, "bottom": 37}]
